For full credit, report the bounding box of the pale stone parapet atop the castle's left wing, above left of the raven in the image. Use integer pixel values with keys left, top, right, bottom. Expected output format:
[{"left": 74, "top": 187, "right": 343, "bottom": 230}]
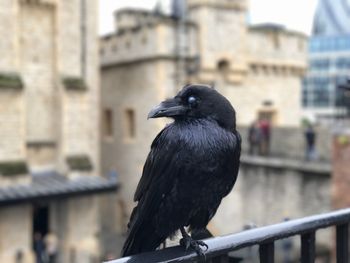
[{"left": 100, "top": 9, "right": 197, "bottom": 66}]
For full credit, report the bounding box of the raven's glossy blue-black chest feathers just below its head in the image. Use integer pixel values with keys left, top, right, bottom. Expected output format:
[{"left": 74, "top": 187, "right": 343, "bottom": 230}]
[{"left": 162, "top": 122, "right": 235, "bottom": 187}]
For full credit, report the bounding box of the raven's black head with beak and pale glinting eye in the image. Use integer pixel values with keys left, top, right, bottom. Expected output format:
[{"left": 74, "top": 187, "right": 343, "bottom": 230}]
[{"left": 148, "top": 84, "right": 236, "bottom": 130}]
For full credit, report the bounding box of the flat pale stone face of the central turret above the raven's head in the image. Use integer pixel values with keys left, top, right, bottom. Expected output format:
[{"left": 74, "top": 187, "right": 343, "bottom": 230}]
[{"left": 189, "top": 1, "right": 247, "bottom": 70}]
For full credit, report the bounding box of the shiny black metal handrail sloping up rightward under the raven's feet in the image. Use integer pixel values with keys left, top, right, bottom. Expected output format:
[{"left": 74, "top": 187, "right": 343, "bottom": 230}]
[{"left": 109, "top": 208, "right": 350, "bottom": 263}]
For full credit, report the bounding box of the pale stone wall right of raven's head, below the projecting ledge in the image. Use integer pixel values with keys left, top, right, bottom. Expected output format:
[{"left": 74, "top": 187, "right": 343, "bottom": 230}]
[{"left": 221, "top": 72, "right": 301, "bottom": 127}]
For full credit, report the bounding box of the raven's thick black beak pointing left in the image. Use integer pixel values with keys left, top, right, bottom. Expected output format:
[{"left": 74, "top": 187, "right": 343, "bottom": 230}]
[{"left": 147, "top": 99, "right": 187, "bottom": 119}]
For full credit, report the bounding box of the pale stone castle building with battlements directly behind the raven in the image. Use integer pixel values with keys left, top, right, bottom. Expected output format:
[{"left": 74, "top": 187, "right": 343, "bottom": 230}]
[{"left": 100, "top": 0, "right": 307, "bottom": 252}]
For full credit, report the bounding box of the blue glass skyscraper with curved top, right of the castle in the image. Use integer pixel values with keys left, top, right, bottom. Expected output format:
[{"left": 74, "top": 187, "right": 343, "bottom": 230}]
[{"left": 303, "top": 0, "right": 350, "bottom": 120}]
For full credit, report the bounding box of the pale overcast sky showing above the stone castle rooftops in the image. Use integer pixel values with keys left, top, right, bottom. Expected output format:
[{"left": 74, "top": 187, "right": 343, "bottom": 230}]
[{"left": 99, "top": 0, "right": 317, "bottom": 34}]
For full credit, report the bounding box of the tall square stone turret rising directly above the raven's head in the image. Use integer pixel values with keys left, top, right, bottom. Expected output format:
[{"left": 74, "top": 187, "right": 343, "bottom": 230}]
[{"left": 187, "top": 0, "right": 247, "bottom": 83}]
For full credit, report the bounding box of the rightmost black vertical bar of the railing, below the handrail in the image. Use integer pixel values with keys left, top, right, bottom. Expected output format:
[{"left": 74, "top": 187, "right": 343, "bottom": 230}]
[{"left": 336, "top": 223, "right": 349, "bottom": 263}]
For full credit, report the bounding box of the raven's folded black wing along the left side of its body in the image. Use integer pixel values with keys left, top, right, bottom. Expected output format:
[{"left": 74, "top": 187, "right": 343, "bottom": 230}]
[{"left": 122, "top": 128, "right": 181, "bottom": 256}]
